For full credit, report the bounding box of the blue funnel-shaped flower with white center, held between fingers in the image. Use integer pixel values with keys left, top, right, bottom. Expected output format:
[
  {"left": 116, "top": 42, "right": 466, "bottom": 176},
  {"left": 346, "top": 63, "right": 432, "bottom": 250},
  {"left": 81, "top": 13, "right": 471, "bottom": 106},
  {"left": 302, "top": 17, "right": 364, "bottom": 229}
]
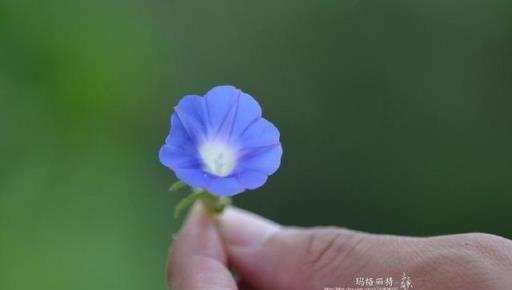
[{"left": 159, "top": 86, "right": 283, "bottom": 196}]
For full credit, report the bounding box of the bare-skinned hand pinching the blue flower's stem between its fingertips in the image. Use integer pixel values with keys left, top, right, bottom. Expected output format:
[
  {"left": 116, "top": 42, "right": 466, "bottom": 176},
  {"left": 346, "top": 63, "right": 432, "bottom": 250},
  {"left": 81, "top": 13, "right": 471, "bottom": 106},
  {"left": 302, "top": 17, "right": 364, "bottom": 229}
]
[{"left": 168, "top": 205, "right": 512, "bottom": 290}]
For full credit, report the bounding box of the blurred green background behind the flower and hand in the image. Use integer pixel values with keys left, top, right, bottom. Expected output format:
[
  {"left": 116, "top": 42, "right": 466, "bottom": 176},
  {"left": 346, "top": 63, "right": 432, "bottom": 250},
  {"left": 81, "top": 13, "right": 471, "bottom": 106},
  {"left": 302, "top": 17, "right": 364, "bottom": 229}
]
[{"left": 0, "top": 0, "right": 512, "bottom": 290}]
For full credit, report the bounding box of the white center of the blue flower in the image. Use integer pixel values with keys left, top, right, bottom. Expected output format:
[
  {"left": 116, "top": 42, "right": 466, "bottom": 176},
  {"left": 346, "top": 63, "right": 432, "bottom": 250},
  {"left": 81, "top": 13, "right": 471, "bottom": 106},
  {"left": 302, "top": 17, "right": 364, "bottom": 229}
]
[{"left": 199, "top": 141, "right": 236, "bottom": 177}]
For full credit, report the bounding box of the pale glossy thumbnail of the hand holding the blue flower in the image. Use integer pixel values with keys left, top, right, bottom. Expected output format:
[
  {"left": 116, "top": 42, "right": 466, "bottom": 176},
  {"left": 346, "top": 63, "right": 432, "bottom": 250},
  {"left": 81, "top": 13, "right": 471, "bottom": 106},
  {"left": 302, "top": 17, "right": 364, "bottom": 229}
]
[{"left": 219, "top": 207, "right": 281, "bottom": 247}]
